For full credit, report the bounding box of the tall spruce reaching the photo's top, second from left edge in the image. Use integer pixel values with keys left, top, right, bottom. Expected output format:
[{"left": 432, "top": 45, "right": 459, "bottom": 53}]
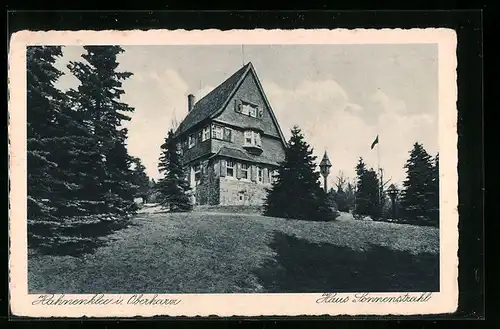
[{"left": 68, "top": 46, "right": 135, "bottom": 214}]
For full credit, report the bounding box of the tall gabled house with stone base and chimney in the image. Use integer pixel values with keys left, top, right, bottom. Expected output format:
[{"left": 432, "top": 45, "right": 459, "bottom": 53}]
[{"left": 175, "top": 63, "right": 286, "bottom": 206}]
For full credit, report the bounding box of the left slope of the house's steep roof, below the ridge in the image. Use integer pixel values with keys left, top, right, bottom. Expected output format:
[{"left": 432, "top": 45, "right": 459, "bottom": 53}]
[{"left": 176, "top": 63, "right": 251, "bottom": 134}]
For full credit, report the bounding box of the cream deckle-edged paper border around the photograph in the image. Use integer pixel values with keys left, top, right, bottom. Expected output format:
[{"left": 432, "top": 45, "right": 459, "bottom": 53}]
[{"left": 8, "top": 28, "right": 458, "bottom": 318}]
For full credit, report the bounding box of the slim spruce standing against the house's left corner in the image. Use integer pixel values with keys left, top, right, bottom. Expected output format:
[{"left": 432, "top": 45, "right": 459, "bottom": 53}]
[{"left": 156, "top": 129, "right": 193, "bottom": 212}]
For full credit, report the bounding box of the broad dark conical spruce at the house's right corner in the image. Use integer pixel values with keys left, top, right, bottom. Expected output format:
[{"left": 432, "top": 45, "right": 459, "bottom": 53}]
[{"left": 264, "top": 126, "right": 334, "bottom": 221}]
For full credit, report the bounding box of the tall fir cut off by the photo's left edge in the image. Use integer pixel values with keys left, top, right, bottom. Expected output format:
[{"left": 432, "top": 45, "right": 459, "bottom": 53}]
[{"left": 26, "top": 46, "right": 63, "bottom": 220}]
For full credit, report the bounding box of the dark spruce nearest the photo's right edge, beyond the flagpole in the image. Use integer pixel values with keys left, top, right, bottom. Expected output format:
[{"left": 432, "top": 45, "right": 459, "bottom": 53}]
[{"left": 401, "top": 143, "right": 435, "bottom": 224}]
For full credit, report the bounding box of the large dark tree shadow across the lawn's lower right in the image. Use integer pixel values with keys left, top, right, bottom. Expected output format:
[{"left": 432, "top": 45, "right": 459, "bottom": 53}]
[{"left": 255, "top": 232, "right": 439, "bottom": 293}]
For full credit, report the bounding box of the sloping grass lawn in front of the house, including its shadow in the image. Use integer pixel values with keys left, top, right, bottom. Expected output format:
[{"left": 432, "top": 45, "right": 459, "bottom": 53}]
[{"left": 28, "top": 212, "right": 439, "bottom": 293}]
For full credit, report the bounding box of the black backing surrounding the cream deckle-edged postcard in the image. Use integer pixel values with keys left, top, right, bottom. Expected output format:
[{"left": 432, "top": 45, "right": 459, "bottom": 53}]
[{"left": 4, "top": 9, "right": 485, "bottom": 327}]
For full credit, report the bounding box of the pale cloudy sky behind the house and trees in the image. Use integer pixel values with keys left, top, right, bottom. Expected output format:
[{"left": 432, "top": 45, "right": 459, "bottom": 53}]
[{"left": 52, "top": 44, "right": 438, "bottom": 186}]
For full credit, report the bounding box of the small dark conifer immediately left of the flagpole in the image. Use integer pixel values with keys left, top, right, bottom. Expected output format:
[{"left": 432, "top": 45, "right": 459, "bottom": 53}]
[{"left": 355, "top": 158, "right": 381, "bottom": 219}]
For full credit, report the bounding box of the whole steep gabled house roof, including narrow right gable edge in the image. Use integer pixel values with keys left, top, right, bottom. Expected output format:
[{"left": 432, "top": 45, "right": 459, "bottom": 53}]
[{"left": 175, "top": 62, "right": 287, "bottom": 146}]
